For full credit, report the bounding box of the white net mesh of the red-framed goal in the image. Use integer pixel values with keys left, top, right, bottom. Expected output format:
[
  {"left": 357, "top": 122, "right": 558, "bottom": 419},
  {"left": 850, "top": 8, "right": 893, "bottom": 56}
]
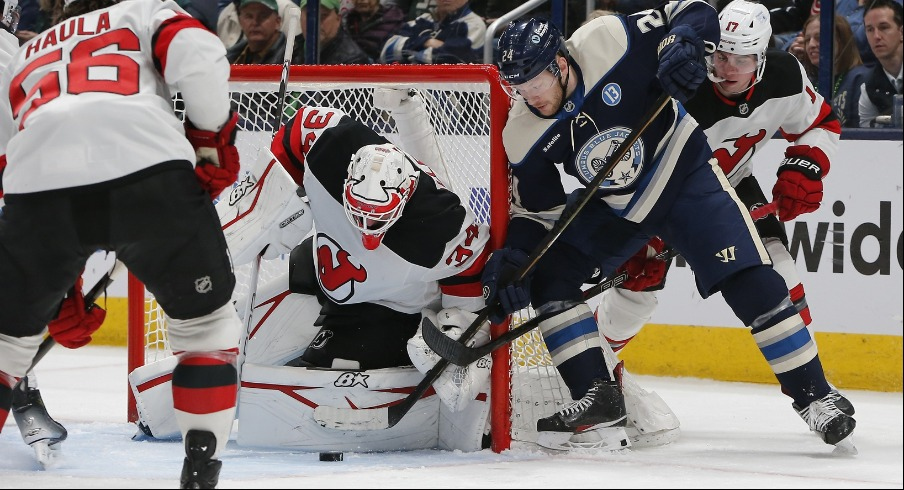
[{"left": 138, "top": 69, "right": 570, "bottom": 448}]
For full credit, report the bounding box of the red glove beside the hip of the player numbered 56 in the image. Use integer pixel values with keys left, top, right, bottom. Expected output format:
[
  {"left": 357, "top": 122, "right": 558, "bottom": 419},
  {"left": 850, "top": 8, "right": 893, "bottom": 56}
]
[{"left": 185, "top": 112, "right": 240, "bottom": 199}]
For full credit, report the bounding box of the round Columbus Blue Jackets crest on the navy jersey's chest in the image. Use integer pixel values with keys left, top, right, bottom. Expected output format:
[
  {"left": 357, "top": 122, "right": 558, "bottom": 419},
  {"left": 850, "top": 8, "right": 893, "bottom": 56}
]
[{"left": 575, "top": 127, "right": 644, "bottom": 190}]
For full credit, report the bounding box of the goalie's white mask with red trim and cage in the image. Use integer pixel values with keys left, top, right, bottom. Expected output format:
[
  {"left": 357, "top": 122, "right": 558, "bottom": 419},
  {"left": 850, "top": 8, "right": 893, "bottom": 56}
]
[{"left": 342, "top": 143, "right": 418, "bottom": 250}]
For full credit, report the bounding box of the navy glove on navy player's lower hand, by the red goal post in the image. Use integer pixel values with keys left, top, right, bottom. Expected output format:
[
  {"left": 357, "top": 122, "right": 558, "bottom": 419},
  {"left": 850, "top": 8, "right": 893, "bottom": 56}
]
[{"left": 480, "top": 248, "right": 530, "bottom": 324}]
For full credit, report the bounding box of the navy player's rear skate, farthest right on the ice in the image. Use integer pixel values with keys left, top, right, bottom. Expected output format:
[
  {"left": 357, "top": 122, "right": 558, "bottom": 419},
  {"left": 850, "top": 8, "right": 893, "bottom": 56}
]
[{"left": 791, "top": 388, "right": 857, "bottom": 455}]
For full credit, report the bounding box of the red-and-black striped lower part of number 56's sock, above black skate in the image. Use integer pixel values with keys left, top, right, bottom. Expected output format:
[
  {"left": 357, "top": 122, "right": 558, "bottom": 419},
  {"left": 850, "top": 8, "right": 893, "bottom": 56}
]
[{"left": 173, "top": 351, "right": 238, "bottom": 459}]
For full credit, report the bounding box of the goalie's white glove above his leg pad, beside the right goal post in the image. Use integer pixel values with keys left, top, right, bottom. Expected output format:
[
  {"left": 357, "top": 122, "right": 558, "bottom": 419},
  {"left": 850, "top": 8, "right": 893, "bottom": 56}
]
[{"left": 407, "top": 308, "right": 493, "bottom": 412}]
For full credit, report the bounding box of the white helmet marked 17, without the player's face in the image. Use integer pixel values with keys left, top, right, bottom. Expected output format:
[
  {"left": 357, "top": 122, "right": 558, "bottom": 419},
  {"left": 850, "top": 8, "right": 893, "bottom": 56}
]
[{"left": 706, "top": 0, "right": 772, "bottom": 86}]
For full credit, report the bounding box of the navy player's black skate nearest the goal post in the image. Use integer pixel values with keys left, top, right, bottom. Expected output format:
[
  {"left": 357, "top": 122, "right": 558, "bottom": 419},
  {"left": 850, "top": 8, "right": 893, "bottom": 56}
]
[{"left": 537, "top": 379, "right": 631, "bottom": 451}]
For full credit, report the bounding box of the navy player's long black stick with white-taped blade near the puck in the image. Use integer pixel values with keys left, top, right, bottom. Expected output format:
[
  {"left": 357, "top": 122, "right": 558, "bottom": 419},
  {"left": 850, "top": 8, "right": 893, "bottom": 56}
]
[{"left": 313, "top": 94, "right": 672, "bottom": 430}]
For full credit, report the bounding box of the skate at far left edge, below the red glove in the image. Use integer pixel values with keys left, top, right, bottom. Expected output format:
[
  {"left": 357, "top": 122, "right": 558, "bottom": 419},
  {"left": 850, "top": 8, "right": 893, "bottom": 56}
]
[{"left": 11, "top": 375, "right": 68, "bottom": 468}]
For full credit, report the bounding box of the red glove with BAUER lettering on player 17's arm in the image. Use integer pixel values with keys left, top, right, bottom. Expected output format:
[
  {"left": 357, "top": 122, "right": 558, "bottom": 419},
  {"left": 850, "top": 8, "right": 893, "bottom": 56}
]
[{"left": 772, "top": 145, "right": 829, "bottom": 221}]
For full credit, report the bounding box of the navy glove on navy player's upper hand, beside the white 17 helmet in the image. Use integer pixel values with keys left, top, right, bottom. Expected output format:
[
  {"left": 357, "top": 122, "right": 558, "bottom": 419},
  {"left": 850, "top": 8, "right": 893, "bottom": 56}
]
[{"left": 656, "top": 25, "right": 706, "bottom": 104}]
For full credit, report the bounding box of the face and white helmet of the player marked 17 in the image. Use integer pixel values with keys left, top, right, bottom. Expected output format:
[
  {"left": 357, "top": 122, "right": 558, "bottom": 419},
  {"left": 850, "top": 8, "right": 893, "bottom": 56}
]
[{"left": 706, "top": 0, "right": 772, "bottom": 90}]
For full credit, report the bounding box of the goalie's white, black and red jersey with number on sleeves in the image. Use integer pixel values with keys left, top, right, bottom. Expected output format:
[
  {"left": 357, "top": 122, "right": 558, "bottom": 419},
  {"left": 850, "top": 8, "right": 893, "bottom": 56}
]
[{"left": 272, "top": 107, "right": 489, "bottom": 313}]
